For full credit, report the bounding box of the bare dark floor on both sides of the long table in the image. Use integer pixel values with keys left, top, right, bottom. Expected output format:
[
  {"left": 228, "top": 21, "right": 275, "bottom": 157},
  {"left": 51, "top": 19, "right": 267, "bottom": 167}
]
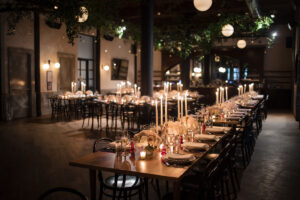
[{"left": 0, "top": 112, "right": 300, "bottom": 200}]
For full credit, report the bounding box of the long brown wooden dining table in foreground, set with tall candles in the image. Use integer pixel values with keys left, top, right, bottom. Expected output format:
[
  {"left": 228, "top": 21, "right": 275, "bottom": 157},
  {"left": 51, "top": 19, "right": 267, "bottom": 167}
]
[{"left": 69, "top": 127, "right": 232, "bottom": 200}]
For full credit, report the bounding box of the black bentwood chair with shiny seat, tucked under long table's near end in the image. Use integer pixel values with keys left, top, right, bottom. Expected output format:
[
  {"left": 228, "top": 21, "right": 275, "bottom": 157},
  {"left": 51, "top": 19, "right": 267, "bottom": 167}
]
[{"left": 93, "top": 138, "right": 144, "bottom": 200}]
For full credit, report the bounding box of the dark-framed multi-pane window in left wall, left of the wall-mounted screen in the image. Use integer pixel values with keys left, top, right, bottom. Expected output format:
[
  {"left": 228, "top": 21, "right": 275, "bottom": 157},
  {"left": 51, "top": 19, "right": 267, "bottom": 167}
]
[{"left": 78, "top": 58, "right": 94, "bottom": 90}]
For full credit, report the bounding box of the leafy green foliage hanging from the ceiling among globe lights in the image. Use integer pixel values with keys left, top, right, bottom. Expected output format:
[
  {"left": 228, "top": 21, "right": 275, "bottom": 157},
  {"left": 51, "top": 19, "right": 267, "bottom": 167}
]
[{"left": 0, "top": 0, "right": 273, "bottom": 58}]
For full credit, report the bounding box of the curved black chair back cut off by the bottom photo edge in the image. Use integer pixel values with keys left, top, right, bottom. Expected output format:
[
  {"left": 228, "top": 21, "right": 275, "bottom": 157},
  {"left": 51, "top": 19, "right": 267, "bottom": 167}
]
[{"left": 39, "top": 187, "right": 88, "bottom": 200}]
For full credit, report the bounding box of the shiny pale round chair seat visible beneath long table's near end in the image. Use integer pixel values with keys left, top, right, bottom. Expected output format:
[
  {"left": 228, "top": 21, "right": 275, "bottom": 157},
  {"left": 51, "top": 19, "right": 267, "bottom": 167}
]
[{"left": 104, "top": 175, "right": 141, "bottom": 189}]
